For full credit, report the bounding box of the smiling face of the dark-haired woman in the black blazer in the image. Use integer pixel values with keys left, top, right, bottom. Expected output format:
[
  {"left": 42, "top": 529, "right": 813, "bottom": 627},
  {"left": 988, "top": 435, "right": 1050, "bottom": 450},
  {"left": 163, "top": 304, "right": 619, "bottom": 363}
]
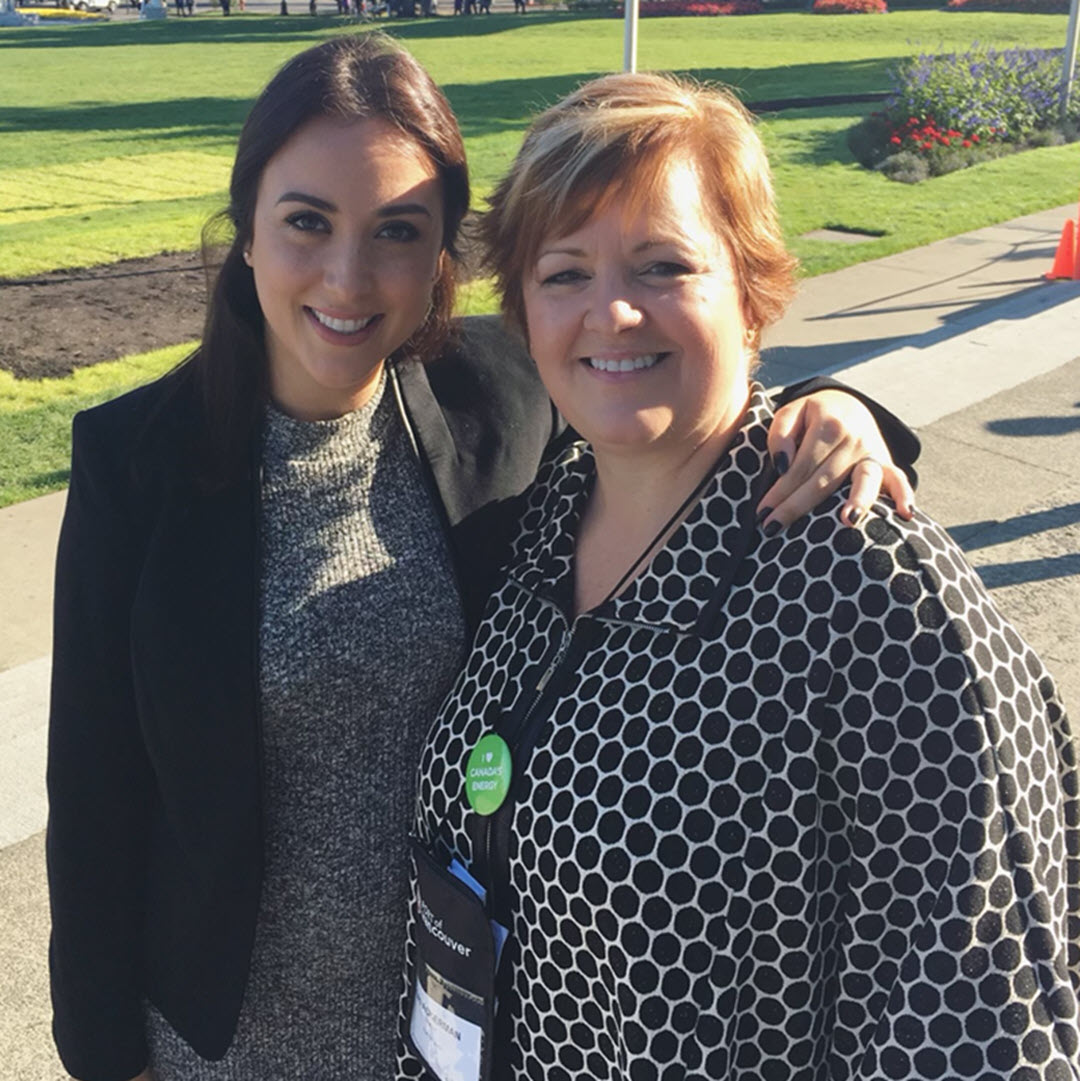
[{"left": 244, "top": 117, "right": 443, "bottom": 419}]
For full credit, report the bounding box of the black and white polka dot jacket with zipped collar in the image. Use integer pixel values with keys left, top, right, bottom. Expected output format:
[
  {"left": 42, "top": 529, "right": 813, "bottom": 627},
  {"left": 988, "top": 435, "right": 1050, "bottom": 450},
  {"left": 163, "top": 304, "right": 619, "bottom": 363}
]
[{"left": 401, "top": 391, "right": 1080, "bottom": 1081}]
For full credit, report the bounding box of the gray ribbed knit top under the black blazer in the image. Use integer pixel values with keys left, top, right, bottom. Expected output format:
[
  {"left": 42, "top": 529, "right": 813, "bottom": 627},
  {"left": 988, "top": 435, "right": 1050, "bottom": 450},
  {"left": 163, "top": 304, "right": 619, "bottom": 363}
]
[{"left": 147, "top": 382, "right": 465, "bottom": 1081}]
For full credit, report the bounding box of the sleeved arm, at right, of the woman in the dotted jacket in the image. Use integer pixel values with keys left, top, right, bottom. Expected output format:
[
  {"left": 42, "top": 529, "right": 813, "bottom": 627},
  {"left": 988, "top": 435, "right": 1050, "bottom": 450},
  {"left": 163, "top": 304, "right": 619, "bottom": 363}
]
[{"left": 823, "top": 516, "right": 1080, "bottom": 1081}]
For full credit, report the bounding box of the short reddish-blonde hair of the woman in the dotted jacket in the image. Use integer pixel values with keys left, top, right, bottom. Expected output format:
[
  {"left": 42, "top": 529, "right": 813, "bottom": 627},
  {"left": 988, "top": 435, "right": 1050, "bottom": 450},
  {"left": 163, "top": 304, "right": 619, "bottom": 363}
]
[{"left": 480, "top": 75, "right": 797, "bottom": 341}]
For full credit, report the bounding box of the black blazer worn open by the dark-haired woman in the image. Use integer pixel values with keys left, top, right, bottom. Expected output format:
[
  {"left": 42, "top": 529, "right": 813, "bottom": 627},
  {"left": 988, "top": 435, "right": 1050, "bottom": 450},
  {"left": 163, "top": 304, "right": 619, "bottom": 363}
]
[{"left": 46, "top": 320, "right": 914, "bottom": 1081}]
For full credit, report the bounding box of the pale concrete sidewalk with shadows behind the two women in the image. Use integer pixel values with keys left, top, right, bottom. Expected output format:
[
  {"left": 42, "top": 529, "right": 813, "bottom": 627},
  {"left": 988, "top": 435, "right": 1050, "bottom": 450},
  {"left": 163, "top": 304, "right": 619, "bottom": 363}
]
[{"left": 0, "top": 205, "right": 1080, "bottom": 1081}]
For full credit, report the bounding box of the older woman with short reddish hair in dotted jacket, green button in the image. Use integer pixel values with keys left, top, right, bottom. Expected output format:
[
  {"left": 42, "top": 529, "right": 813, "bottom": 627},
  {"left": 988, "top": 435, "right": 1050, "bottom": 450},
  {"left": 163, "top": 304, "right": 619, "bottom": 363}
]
[{"left": 401, "top": 76, "right": 1080, "bottom": 1081}]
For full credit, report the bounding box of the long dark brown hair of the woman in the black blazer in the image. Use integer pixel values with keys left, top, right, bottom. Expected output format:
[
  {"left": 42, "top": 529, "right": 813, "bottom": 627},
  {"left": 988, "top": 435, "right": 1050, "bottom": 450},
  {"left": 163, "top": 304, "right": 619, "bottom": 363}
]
[{"left": 187, "top": 34, "right": 469, "bottom": 482}]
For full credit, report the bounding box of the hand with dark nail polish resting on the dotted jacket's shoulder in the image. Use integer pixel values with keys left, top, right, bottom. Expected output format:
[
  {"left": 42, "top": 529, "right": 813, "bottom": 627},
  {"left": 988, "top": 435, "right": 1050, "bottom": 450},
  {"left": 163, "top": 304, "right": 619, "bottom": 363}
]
[{"left": 758, "top": 390, "right": 915, "bottom": 530}]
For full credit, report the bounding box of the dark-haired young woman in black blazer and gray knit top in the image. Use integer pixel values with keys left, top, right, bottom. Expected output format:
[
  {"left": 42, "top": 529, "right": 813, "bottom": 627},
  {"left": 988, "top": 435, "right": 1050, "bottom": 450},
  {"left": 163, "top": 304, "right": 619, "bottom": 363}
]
[{"left": 48, "top": 36, "right": 905, "bottom": 1081}]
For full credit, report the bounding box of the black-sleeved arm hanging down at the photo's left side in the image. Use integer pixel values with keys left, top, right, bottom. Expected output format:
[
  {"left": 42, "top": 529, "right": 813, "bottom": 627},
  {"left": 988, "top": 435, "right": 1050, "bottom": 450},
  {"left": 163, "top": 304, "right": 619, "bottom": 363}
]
[{"left": 46, "top": 414, "right": 149, "bottom": 1081}]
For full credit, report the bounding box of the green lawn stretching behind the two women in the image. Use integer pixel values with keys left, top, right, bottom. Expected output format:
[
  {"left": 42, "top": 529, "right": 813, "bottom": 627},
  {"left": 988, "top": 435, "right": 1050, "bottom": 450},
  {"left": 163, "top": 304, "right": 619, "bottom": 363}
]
[{"left": 0, "top": 11, "right": 1080, "bottom": 506}]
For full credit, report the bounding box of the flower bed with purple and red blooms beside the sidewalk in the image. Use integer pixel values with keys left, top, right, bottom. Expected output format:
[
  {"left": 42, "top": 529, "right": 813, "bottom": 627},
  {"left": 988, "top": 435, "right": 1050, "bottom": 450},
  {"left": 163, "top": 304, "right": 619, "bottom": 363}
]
[{"left": 848, "top": 45, "right": 1080, "bottom": 184}]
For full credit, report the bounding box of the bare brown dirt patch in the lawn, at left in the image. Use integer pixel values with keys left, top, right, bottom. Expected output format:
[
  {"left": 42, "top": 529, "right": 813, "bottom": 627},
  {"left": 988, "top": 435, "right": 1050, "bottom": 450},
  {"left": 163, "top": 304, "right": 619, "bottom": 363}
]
[{"left": 0, "top": 252, "right": 206, "bottom": 379}]
